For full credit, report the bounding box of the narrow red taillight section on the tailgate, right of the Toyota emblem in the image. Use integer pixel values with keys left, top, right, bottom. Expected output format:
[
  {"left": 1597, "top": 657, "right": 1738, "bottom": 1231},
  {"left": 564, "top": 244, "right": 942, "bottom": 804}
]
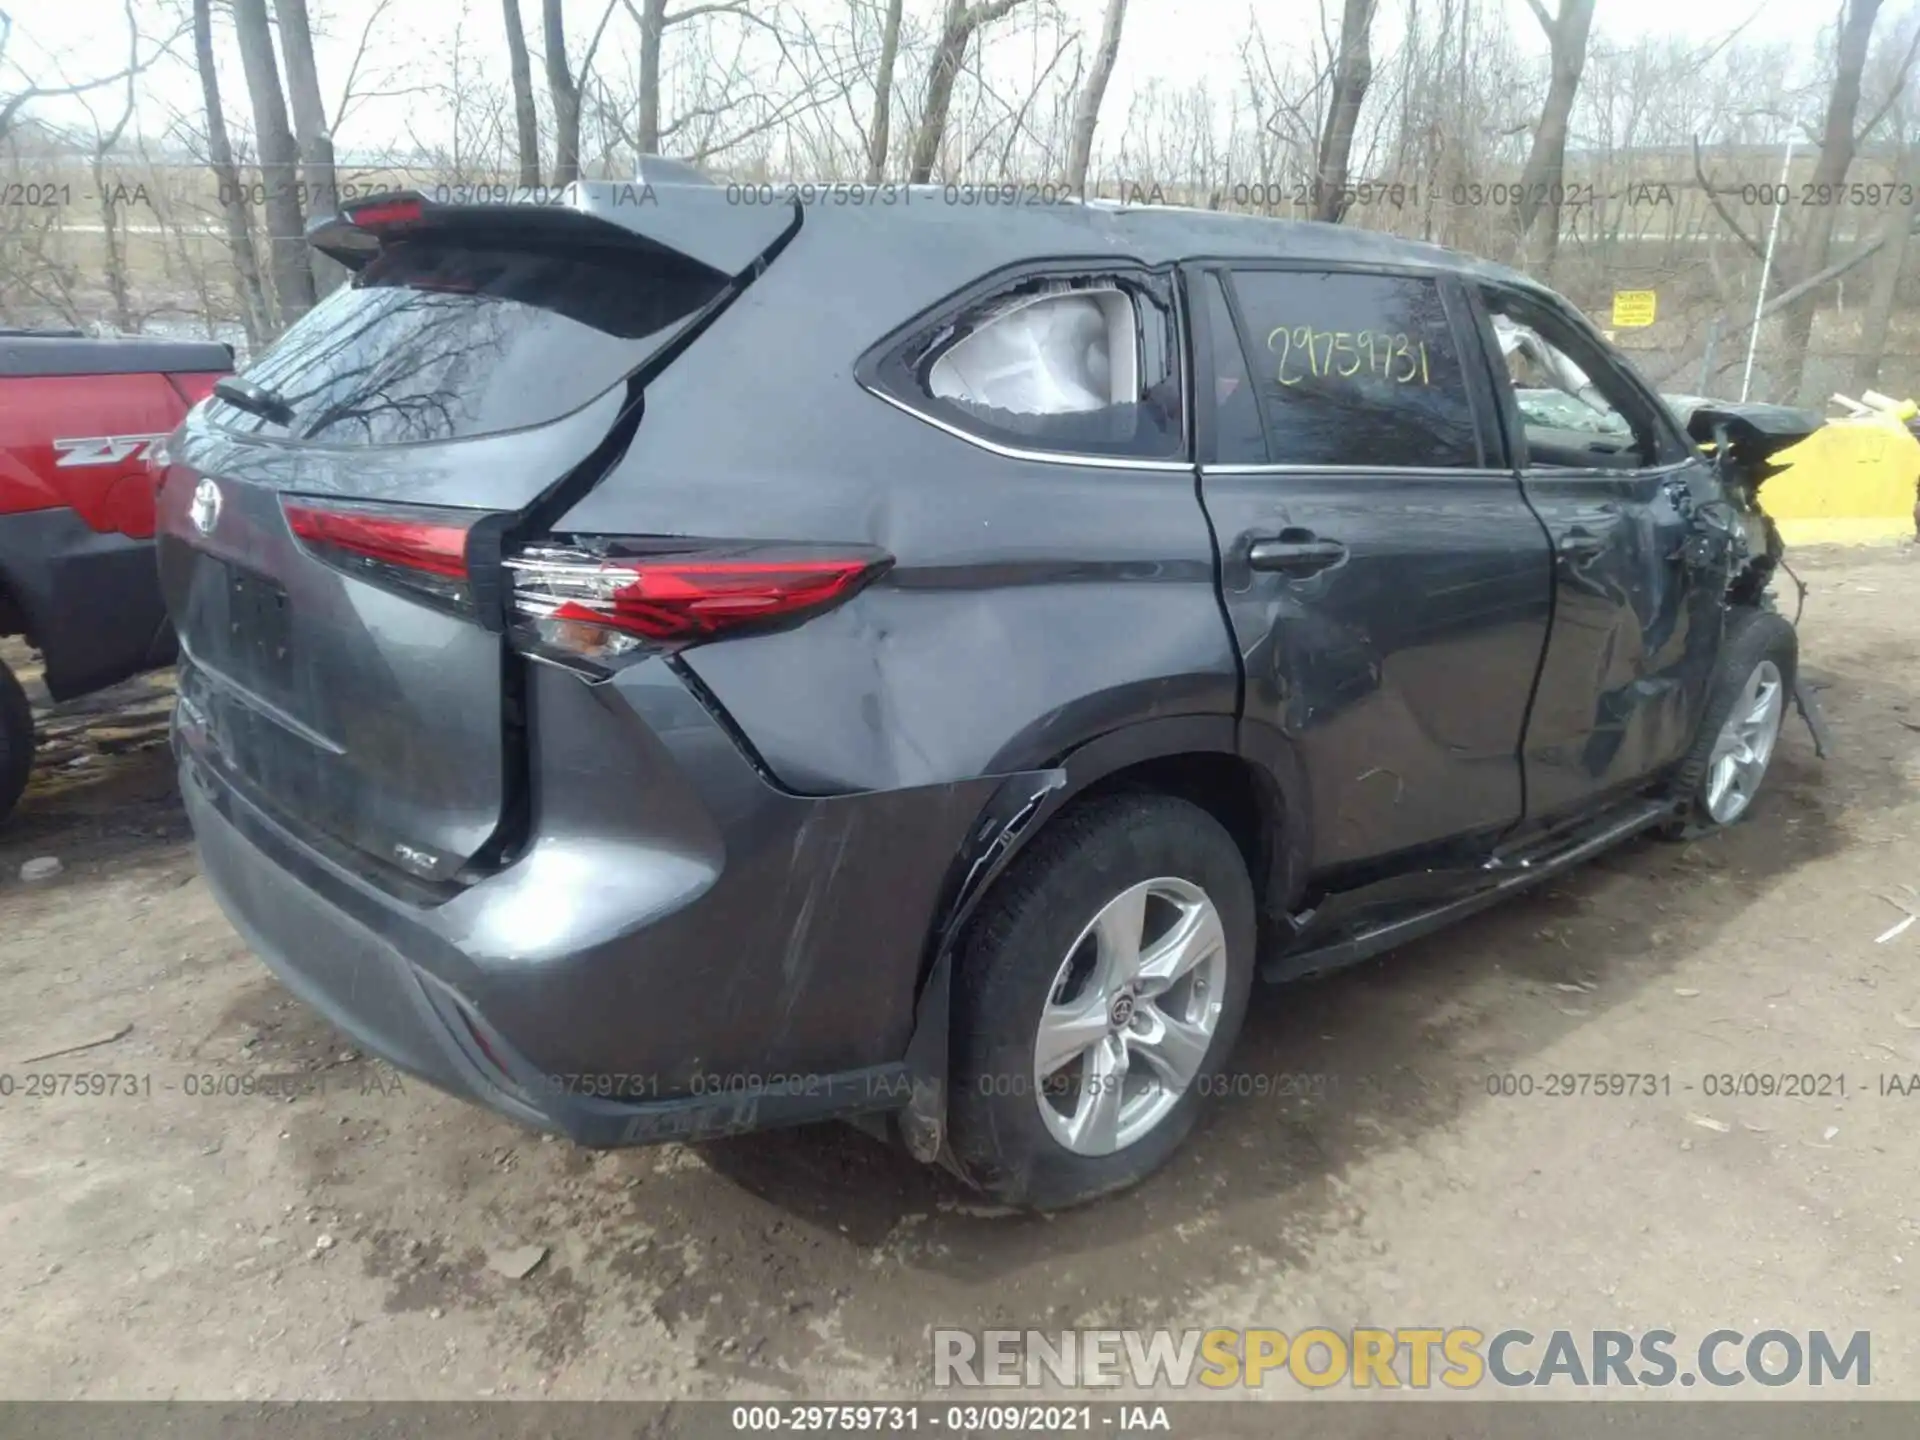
[{"left": 280, "top": 495, "right": 482, "bottom": 611}]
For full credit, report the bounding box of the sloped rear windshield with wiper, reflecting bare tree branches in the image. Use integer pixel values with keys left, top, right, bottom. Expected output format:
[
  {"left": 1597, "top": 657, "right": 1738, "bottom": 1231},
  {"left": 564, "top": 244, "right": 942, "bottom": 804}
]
[{"left": 207, "top": 240, "right": 724, "bottom": 445}]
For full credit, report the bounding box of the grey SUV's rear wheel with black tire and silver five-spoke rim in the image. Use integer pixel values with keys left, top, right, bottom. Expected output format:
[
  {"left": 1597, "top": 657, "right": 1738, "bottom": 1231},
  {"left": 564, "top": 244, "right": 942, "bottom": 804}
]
[{"left": 948, "top": 795, "right": 1254, "bottom": 1210}]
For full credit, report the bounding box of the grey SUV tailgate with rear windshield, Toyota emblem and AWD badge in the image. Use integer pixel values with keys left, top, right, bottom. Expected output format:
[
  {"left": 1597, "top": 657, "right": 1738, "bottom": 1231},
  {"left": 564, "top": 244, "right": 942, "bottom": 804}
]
[{"left": 159, "top": 192, "right": 783, "bottom": 879}]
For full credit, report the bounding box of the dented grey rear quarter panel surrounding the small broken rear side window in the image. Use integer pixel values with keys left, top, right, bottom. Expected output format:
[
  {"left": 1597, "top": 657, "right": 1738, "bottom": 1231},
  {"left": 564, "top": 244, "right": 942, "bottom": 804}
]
[{"left": 555, "top": 200, "right": 1236, "bottom": 793}]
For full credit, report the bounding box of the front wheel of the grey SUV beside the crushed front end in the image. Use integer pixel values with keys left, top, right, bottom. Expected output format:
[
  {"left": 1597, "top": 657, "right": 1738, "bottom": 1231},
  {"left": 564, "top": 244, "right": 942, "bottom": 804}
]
[{"left": 1667, "top": 609, "right": 1799, "bottom": 839}]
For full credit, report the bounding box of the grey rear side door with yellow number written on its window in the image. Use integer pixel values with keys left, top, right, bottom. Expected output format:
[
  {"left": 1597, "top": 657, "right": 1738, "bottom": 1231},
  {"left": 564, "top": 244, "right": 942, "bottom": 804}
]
[{"left": 1188, "top": 265, "right": 1551, "bottom": 870}]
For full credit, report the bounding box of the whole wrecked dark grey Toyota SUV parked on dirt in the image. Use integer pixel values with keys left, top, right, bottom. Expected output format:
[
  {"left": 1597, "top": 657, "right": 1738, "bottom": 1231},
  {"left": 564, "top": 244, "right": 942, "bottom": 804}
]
[{"left": 161, "top": 184, "right": 1795, "bottom": 1206}]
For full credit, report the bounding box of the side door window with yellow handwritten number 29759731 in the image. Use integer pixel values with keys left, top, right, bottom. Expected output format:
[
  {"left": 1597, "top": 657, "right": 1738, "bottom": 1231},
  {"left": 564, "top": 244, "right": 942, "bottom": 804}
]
[{"left": 1233, "top": 271, "right": 1480, "bottom": 468}]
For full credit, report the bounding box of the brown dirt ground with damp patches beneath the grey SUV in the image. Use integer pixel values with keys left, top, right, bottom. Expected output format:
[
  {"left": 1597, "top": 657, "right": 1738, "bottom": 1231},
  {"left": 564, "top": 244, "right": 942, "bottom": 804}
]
[{"left": 0, "top": 547, "right": 1920, "bottom": 1400}]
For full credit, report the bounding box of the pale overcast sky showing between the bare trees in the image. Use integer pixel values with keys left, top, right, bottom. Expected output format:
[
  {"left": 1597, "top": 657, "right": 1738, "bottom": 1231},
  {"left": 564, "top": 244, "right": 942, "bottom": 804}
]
[{"left": 0, "top": 0, "right": 1827, "bottom": 150}]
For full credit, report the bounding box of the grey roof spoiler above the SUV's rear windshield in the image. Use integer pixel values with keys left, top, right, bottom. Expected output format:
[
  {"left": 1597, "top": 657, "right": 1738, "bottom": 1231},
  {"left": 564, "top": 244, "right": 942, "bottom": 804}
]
[{"left": 307, "top": 179, "right": 801, "bottom": 278}]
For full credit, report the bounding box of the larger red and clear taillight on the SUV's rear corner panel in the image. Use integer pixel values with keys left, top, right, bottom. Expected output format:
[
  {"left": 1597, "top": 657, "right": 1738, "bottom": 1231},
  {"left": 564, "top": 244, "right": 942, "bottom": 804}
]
[{"left": 507, "top": 540, "right": 893, "bottom": 662}]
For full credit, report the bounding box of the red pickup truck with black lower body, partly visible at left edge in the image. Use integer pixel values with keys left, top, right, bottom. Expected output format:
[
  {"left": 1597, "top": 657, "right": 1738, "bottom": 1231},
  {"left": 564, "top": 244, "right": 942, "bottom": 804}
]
[{"left": 0, "top": 330, "right": 234, "bottom": 818}]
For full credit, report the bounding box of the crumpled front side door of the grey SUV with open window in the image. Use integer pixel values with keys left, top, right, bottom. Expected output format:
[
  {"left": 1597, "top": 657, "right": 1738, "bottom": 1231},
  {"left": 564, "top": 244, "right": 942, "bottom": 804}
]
[{"left": 1475, "top": 286, "right": 1724, "bottom": 822}]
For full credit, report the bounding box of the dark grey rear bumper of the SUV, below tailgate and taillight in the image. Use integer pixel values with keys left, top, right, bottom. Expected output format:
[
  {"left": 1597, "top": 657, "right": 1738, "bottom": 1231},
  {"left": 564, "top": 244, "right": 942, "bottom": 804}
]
[{"left": 175, "top": 656, "right": 1021, "bottom": 1146}]
